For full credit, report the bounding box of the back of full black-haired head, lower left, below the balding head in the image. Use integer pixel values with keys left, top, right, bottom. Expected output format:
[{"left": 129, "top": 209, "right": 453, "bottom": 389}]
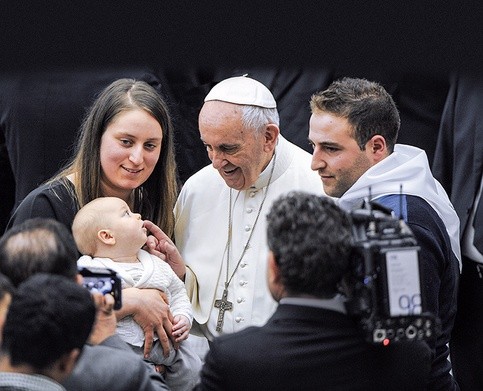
[{"left": 1, "top": 273, "right": 96, "bottom": 373}]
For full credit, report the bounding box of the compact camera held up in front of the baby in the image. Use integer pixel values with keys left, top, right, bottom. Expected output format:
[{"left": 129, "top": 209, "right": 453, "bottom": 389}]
[{"left": 79, "top": 267, "right": 122, "bottom": 310}]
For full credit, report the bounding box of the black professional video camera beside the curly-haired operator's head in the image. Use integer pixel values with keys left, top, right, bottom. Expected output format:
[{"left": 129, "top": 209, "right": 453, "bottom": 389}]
[{"left": 343, "top": 200, "right": 440, "bottom": 345}]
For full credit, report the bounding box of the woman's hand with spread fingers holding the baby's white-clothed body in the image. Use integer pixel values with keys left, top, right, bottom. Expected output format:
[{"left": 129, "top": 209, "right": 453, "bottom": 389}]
[{"left": 116, "top": 288, "right": 178, "bottom": 357}]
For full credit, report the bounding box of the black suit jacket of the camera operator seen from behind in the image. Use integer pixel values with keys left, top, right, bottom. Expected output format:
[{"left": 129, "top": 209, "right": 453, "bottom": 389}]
[{"left": 197, "top": 304, "right": 431, "bottom": 391}]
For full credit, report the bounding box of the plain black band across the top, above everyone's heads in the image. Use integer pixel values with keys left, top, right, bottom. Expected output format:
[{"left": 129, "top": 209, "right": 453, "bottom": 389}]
[{"left": 0, "top": 0, "right": 483, "bottom": 78}]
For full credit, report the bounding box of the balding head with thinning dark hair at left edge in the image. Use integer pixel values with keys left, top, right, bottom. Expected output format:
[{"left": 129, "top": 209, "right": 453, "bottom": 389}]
[{"left": 0, "top": 217, "right": 79, "bottom": 286}]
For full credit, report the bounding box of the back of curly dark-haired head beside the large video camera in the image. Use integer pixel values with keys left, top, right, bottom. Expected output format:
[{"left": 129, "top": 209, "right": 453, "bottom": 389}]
[{"left": 267, "top": 192, "right": 352, "bottom": 300}]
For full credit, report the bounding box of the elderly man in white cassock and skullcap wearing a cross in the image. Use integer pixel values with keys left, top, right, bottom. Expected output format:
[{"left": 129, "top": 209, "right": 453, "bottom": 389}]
[{"left": 174, "top": 76, "right": 324, "bottom": 352}]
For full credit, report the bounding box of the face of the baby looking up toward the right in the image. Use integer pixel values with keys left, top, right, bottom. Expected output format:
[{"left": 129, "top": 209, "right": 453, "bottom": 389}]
[{"left": 105, "top": 198, "right": 147, "bottom": 248}]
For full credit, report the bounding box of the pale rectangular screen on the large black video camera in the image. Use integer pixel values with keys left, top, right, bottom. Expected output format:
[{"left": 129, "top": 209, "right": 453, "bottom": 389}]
[{"left": 386, "top": 248, "right": 422, "bottom": 316}]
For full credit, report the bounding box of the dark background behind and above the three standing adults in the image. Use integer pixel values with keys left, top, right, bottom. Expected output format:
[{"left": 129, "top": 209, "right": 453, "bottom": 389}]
[{"left": 0, "top": 0, "right": 483, "bottom": 232}]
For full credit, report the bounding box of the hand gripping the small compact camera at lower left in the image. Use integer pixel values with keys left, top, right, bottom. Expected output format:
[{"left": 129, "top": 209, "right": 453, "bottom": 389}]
[{"left": 88, "top": 293, "right": 117, "bottom": 345}]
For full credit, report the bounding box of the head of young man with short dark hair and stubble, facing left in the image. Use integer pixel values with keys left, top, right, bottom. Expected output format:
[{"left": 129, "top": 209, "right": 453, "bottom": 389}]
[{"left": 309, "top": 78, "right": 400, "bottom": 197}]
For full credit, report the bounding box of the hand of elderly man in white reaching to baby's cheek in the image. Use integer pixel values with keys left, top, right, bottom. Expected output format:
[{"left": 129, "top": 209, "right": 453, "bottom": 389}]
[{"left": 144, "top": 220, "right": 186, "bottom": 280}]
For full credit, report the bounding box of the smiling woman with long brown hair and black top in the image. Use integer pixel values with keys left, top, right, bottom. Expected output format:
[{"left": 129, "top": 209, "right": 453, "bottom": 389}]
[{"left": 9, "top": 79, "right": 178, "bottom": 236}]
